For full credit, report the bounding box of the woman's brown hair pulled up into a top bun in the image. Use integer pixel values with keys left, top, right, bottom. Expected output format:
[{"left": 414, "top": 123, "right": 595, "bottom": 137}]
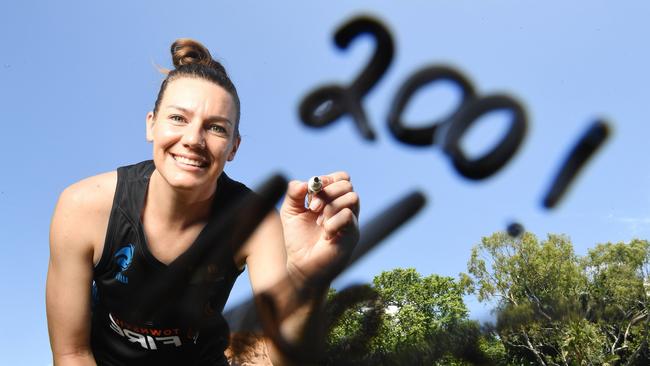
[{"left": 153, "top": 38, "right": 240, "bottom": 137}]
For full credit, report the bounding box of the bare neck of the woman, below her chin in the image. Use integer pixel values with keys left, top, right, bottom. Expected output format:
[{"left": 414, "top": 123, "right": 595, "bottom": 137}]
[{"left": 142, "top": 170, "right": 216, "bottom": 229}]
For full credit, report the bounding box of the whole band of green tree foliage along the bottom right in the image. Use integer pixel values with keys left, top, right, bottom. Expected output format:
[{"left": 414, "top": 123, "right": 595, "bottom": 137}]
[{"left": 320, "top": 232, "right": 650, "bottom": 366}]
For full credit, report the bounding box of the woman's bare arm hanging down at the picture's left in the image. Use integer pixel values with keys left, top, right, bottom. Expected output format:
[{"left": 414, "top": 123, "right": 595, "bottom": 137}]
[{"left": 46, "top": 175, "right": 116, "bottom": 366}]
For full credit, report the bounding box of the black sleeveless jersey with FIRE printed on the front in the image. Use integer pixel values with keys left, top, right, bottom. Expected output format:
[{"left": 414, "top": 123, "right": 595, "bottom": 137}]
[{"left": 91, "top": 161, "right": 250, "bottom": 366}]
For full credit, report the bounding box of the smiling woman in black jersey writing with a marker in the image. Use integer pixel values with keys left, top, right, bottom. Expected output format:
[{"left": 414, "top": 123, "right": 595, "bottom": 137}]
[{"left": 46, "top": 39, "right": 359, "bottom": 365}]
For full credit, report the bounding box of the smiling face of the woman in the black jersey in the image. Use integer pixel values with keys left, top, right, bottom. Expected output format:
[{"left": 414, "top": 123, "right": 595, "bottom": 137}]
[{"left": 147, "top": 77, "right": 240, "bottom": 194}]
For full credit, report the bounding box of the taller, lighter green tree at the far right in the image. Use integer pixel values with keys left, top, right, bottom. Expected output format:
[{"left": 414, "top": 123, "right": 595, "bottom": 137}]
[{"left": 468, "top": 232, "right": 649, "bottom": 365}]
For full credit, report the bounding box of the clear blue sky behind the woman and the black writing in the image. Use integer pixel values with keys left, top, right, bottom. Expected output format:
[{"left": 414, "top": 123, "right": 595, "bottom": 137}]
[{"left": 0, "top": 0, "right": 650, "bottom": 365}]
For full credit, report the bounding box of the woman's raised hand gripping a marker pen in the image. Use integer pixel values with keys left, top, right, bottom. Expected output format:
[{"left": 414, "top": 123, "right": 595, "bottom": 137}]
[{"left": 280, "top": 172, "right": 359, "bottom": 285}]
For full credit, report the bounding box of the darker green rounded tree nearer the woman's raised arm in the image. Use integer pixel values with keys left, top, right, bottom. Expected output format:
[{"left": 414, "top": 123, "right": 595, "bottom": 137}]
[{"left": 328, "top": 268, "right": 498, "bottom": 365}]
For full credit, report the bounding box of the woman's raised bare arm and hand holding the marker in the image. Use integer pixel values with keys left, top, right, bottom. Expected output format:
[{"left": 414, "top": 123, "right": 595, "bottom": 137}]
[{"left": 239, "top": 172, "right": 359, "bottom": 366}]
